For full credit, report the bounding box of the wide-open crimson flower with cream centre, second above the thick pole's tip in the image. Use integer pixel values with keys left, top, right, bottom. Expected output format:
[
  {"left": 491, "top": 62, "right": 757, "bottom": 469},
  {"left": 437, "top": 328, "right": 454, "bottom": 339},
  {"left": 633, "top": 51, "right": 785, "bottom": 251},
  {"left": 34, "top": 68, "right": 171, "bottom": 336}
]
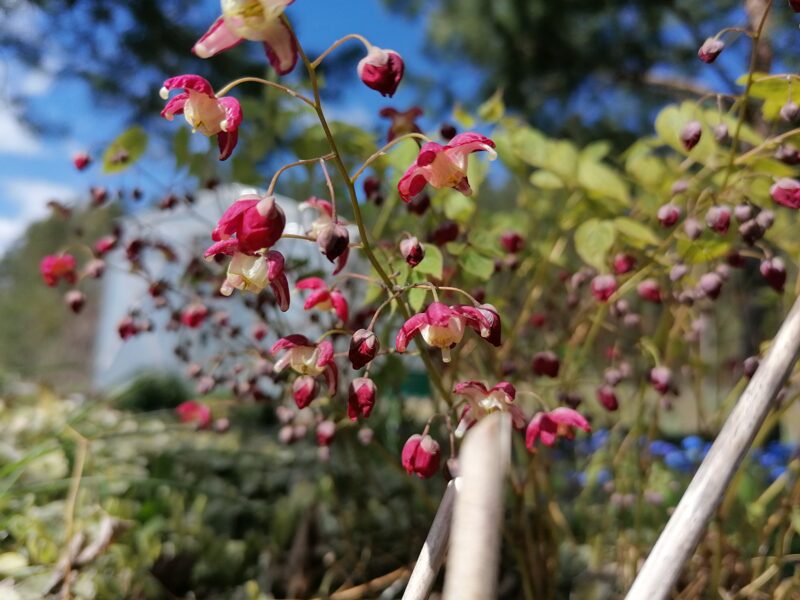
[{"left": 395, "top": 302, "right": 500, "bottom": 362}]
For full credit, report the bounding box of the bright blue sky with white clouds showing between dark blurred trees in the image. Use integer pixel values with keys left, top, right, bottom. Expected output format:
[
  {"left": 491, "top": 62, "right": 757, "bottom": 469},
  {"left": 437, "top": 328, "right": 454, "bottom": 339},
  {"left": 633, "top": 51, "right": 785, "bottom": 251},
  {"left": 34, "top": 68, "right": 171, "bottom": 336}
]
[{"left": 0, "top": 0, "right": 478, "bottom": 254}]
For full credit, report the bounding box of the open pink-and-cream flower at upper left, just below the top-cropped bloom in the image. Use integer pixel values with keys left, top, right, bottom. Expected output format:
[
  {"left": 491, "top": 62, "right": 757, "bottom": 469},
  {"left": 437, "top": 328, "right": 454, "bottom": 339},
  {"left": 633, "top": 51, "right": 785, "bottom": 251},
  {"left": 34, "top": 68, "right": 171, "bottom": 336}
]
[{"left": 161, "top": 75, "right": 242, "bottom": 160}]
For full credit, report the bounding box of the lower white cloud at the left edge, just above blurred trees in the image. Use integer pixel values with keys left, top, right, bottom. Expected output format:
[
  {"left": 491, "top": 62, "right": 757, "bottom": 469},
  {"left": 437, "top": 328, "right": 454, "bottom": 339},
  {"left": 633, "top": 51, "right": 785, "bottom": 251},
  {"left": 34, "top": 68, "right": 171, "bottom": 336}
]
[{"left": 0, "top": 178, "right": 75, "bottom": 255}]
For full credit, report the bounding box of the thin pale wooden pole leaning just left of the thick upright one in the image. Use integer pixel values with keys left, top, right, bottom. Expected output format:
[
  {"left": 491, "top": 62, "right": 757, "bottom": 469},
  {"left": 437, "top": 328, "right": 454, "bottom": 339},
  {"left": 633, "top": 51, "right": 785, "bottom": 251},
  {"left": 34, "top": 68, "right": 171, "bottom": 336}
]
[{"left": 403, "top": 478, "right": 461, "bottom": 600}]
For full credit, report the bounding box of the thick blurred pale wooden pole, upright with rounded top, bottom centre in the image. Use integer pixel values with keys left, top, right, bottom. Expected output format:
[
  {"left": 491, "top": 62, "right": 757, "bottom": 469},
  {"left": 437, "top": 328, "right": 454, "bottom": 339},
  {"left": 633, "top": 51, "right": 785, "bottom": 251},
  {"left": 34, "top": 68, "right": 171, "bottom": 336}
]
[{"left": 444, "top": 413, "right": 511, "bottom": 600}]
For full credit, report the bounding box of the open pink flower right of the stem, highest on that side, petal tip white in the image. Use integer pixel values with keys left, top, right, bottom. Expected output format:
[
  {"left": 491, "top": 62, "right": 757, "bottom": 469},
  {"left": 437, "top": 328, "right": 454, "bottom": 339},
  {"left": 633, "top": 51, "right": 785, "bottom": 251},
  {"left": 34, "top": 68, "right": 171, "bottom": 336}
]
[{"left": 397, "top": 133, "right": 497, "bottom": 202}]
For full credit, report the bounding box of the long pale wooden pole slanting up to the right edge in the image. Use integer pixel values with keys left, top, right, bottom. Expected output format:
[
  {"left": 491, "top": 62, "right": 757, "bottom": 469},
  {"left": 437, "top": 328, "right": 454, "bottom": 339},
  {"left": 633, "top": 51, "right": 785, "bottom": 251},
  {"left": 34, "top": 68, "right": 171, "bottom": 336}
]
[{"left": 626, "top": 299, "right": 800, "bottom": 600}]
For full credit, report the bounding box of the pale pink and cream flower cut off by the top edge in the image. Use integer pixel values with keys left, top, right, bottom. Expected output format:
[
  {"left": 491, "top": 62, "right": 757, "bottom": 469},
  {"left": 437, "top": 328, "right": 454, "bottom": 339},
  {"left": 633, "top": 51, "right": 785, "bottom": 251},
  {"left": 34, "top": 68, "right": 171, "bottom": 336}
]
[{"left": 192, "top": 0, "right": 297, "bottom": 75}]
